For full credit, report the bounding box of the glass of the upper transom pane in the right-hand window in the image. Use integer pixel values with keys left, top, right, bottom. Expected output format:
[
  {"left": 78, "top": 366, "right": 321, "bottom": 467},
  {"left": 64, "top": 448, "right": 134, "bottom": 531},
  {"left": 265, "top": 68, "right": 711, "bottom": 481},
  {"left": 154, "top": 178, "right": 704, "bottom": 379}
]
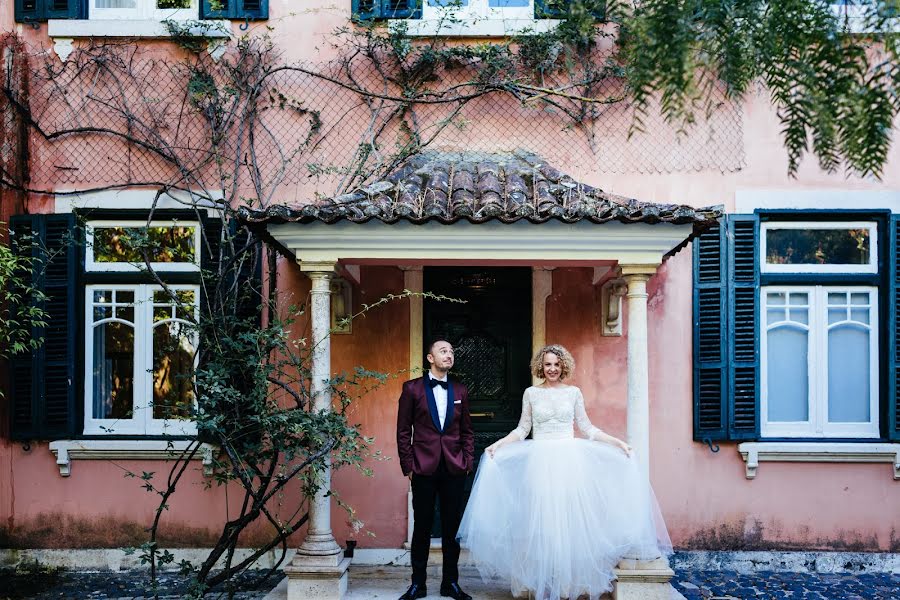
[{"left": 766, "top": 229, "right": 870, "bottom": 265}]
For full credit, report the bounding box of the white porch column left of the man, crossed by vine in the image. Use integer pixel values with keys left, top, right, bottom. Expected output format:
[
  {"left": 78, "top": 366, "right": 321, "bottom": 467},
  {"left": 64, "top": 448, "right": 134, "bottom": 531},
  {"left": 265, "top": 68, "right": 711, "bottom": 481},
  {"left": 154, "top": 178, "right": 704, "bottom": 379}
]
[{"left": 284, "top": 262, "right": 350, "bottom": 600}]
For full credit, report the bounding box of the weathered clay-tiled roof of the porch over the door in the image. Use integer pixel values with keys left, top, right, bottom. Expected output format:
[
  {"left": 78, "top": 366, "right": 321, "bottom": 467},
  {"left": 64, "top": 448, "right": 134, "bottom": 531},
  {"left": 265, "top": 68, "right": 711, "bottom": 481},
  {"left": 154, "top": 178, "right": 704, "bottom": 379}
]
[{"left": 241, "top": 152, "right": 722, "bottom": 229}]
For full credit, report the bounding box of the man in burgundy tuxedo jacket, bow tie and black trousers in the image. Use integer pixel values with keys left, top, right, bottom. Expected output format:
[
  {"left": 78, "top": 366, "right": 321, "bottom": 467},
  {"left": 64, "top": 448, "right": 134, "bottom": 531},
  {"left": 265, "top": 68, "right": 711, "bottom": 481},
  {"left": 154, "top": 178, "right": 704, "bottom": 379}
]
[{"left": 397, "top": 340, "right": 475, "bottom": 600}]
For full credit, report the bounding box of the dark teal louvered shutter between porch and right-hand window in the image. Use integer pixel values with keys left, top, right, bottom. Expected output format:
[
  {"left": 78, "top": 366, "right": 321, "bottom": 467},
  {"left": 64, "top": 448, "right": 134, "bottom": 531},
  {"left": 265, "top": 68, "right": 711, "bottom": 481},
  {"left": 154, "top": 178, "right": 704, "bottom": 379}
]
[{"left": 694, "top": 215, "right": 759, "bottom": 441}]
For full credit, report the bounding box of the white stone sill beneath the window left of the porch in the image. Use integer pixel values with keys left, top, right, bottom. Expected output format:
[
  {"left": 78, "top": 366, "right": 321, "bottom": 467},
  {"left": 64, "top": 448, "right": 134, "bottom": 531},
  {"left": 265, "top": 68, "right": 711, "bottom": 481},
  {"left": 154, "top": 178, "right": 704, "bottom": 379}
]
[{"left": 50, "top": 440, "right": 218, "bottom": 477}]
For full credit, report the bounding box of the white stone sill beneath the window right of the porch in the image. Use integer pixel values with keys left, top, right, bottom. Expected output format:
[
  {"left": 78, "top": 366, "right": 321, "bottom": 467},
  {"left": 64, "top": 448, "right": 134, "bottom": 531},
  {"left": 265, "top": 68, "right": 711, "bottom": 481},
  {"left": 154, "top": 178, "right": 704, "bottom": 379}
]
[{"left": 738, "top": 442, "right": 900, "bottom": 480}]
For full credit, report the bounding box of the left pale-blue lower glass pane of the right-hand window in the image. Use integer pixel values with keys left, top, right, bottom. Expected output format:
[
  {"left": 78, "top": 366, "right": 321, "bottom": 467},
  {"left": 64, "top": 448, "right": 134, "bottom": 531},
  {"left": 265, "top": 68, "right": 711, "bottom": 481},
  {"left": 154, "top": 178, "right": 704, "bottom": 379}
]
[{"left": 766, "top": 326, "right": 809, "bottom": 421}]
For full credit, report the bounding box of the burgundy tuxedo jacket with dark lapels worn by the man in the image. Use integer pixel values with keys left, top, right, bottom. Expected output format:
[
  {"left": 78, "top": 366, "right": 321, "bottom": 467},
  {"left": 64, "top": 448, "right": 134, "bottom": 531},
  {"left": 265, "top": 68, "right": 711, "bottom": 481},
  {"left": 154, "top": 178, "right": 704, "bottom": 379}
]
[{"left": 397, "top": 375, "right": 475, "bottom": 475}]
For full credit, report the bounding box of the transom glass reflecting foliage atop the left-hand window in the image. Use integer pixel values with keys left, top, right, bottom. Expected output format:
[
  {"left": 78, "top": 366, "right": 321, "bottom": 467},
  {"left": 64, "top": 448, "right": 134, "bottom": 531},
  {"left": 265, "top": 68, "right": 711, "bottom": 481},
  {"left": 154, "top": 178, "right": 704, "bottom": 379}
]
[{"left": 93, "top": 226, "right": 196, "bottom": 263}]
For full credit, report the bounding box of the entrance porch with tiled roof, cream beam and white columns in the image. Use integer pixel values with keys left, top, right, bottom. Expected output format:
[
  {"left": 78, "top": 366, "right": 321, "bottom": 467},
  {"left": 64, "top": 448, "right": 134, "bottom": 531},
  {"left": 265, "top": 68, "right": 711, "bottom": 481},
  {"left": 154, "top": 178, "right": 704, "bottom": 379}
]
[{"left": 241, "top": 153, "right": 722, "bottom": 600}]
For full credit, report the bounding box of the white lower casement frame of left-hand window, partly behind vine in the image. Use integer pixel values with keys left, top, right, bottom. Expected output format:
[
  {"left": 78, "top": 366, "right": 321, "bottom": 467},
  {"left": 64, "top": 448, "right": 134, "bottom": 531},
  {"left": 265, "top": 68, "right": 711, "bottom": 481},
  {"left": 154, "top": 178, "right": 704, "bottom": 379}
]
[{"left": 84, "top": 283, "right": 200, "bottom": 436}]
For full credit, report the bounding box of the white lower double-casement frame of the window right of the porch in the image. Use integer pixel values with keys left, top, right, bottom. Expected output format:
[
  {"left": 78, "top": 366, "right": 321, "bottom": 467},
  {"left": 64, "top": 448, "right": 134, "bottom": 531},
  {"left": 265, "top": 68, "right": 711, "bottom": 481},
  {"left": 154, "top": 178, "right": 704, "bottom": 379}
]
[{"left": 759, "top": 285, "right": 880, "bottom": 438}]
